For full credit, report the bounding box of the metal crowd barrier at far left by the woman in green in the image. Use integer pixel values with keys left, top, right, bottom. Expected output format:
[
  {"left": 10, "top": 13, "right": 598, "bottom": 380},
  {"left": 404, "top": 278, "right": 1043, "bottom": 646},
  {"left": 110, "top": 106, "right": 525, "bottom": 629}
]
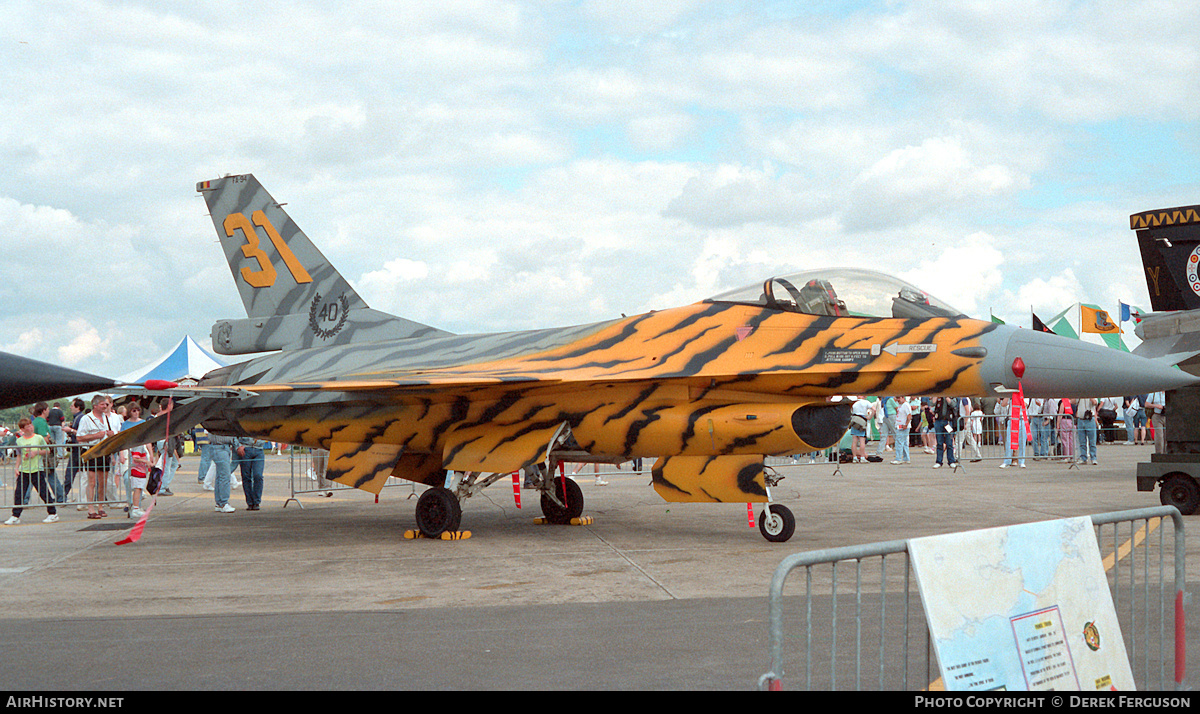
[{"left": 0, "top": 444, "right": 133, "bottom": 514}]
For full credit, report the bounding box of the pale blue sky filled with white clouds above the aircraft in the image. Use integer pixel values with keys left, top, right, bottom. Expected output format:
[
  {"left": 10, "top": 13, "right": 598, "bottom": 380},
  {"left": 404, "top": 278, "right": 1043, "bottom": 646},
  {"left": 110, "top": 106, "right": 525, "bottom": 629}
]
[{"left": 0, "top": 0, "right": 1200, "bottom": 376}]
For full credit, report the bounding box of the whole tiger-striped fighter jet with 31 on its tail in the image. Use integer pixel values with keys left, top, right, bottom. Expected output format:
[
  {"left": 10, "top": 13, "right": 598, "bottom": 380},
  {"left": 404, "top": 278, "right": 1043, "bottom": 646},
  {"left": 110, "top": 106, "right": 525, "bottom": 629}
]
[{"left": 87, "top": 175, "right": 1195, "bottom": 541}]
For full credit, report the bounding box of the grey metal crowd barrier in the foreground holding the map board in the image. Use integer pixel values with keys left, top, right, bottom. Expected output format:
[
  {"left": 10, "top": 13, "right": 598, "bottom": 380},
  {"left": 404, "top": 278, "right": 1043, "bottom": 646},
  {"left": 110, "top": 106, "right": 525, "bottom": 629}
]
[{"left": 758, "top": 506, "right": 1187, "bottom": 690}]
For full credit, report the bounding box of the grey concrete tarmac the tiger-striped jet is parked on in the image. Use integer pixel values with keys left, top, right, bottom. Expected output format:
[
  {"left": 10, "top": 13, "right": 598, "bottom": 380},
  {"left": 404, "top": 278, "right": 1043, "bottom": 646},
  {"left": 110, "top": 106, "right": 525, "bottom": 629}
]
[{"left": 0, "top": 443, "right": 1200, "bottom": 691}]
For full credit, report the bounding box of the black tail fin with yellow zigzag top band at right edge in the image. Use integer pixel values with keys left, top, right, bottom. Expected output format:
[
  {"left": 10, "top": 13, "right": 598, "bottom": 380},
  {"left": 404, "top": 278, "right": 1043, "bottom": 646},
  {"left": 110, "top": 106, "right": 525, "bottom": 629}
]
[{"left": 1129, "top": 205, "right": 1200, "bottom": 312}]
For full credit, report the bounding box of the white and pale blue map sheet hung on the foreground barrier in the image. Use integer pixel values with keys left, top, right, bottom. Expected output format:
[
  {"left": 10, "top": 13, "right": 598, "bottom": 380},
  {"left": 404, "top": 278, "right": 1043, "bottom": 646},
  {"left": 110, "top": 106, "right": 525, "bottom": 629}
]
[{"left": 908, "top": 516, "right": 1134, "bottom": 691}]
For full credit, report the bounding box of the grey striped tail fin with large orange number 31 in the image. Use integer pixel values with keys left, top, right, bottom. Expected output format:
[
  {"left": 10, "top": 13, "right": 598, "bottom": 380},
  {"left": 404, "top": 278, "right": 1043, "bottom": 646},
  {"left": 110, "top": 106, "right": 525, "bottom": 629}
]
[{"left": 196, "top": 174, "right": 448, "bottom": 354}]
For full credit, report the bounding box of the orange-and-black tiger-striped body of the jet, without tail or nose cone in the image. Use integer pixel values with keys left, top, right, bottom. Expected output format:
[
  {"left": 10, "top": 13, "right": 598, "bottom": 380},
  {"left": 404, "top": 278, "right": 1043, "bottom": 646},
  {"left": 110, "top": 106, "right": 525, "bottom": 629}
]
[{"left": 187, "top": 302, "right": 994, "bottom": 502}]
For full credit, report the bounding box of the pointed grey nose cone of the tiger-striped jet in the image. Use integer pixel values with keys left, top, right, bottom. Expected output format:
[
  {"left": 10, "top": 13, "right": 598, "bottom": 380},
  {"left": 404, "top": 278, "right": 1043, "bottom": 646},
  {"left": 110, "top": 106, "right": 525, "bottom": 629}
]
[{"left": 984, "top": 325, "right": 1200, "bottom": 397}]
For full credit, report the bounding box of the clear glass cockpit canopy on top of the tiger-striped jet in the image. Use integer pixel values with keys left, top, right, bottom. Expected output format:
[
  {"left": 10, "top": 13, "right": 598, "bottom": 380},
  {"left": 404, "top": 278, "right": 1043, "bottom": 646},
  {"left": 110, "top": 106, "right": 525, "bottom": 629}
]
[{"left": 706, "top": 268, "right": 962, "bottom": 318}]
